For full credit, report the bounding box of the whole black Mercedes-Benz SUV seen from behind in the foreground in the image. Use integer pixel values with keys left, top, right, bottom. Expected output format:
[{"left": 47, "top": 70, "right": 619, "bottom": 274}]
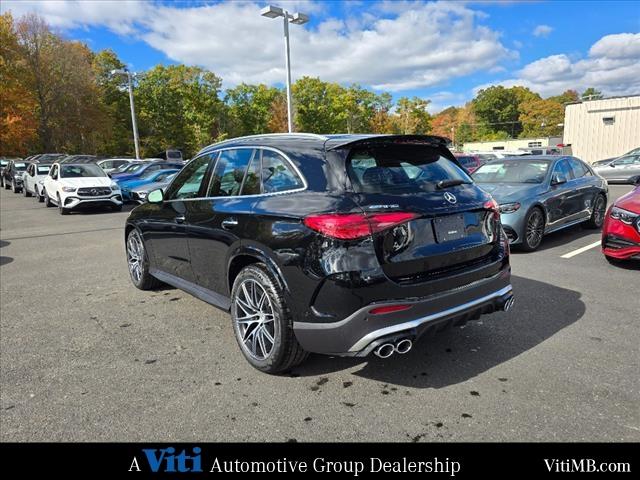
[{"left": 125, "top": 133, "right": 513, "bottom": 373}]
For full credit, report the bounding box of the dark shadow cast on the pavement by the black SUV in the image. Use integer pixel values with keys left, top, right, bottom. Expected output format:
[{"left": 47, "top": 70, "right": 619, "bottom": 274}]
[{"left": 290, "top": 276, "right": 585, "bottom": 388}]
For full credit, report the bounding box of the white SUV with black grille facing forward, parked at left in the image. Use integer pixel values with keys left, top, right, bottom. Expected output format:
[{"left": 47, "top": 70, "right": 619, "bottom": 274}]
[{"left": 44, "top": 163, "right": 122, "bottom": 215}]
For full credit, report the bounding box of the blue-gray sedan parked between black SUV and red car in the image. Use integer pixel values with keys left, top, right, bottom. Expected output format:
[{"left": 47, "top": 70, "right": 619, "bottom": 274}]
[{"left": 472, "top": 155, "right": 608, "bottom": 251}]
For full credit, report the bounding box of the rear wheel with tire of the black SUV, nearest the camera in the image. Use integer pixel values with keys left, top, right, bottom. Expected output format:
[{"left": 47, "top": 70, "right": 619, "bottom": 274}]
[{"left": 231, "top": 263, "right": 308, "bottom": 374}]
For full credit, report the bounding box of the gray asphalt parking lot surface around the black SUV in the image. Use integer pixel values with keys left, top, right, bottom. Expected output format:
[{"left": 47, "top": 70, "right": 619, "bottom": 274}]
[{"left": 0, "top": 186, "right": 640, "bottom": 442}]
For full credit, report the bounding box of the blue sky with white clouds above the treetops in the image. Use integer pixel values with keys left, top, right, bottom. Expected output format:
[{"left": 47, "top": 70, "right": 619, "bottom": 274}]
[{"left": 0, "top": 0, "right": 640, "bottom": 112}]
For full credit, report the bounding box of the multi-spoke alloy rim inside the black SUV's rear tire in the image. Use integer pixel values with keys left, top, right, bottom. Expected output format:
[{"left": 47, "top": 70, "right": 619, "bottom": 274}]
[{"left": 233, "top": 279, "right": 277, "bottom": 360}]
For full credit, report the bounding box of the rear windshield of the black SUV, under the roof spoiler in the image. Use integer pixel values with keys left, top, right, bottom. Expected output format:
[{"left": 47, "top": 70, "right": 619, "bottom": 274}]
[{"left": 347, "top": 145, "right": 471, "bottom": 193}]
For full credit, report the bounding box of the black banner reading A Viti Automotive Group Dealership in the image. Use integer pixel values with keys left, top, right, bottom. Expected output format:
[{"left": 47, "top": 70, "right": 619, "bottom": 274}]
[{"left": 1, "top": 443, "right": 639, "bottom": 478}]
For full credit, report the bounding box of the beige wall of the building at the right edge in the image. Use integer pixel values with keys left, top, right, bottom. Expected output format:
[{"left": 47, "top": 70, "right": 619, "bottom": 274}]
[{"left": 564, "top": 95, "right": 640, "bottom": 162}]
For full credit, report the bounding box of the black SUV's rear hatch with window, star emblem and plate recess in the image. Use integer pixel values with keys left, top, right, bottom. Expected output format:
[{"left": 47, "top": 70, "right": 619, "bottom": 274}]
[{"left": 347, "top": 142, "right": 499, "bottom": 283}]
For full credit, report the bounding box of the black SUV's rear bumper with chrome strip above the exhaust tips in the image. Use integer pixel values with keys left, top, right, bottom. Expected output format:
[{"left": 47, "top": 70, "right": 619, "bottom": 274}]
[{"left": 293, "top": 266, "right": 513, "bottom": 357}]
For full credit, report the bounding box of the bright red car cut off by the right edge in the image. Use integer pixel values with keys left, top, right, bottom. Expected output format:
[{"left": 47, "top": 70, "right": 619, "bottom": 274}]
[{"left": 602, "top": 184, "right": 640, "bottom": 261}]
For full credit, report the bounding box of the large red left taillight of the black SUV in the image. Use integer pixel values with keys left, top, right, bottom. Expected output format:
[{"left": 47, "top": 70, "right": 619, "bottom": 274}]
[{"left": 304, "top": 212, "right": 418, "bottom": 240}]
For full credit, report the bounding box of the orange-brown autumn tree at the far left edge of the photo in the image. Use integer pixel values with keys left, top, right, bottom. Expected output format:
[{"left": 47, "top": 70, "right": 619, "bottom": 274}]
[{"left": 0, "top": 13, "right": 37, "bottom": 155}]
